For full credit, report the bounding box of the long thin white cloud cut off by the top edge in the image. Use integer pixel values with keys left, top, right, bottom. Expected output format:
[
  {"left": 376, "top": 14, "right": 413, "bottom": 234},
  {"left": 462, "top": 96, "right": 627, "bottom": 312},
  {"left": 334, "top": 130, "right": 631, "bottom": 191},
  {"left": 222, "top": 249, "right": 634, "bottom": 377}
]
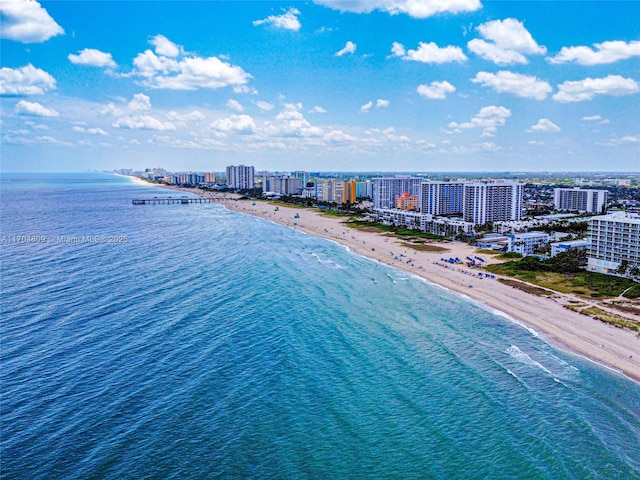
[{"left": 313, "top": 0, "right": 481, "bottom": 18}]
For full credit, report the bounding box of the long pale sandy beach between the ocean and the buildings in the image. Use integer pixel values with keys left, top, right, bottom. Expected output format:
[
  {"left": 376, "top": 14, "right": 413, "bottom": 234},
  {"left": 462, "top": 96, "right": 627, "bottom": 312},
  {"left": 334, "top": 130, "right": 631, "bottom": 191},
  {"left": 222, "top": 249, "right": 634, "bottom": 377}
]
[{"left": 130, "top": 177, "right": 640, "bottom": 383}]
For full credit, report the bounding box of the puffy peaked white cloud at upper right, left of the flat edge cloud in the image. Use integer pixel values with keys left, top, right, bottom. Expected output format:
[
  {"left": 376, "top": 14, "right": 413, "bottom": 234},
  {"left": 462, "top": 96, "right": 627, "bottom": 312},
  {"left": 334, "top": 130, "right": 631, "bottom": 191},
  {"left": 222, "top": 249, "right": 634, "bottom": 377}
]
[{"left": 467, "top": 18, "right": 547, "bottom": 65}]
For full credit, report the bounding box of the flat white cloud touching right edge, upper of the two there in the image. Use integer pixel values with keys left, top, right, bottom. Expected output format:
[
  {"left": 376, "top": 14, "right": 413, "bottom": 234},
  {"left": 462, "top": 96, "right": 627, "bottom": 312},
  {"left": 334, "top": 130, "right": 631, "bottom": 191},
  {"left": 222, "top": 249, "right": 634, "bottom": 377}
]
[{"left": 547, "top": 40, "right": 640, "bottom": 65}]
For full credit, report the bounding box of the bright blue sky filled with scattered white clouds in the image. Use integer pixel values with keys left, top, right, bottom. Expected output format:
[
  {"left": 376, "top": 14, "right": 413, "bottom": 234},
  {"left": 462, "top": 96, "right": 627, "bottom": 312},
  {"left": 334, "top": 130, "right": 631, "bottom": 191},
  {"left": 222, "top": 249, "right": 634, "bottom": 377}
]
[{"left": 0, "top": 0, "right": 640, "bottom": 172}]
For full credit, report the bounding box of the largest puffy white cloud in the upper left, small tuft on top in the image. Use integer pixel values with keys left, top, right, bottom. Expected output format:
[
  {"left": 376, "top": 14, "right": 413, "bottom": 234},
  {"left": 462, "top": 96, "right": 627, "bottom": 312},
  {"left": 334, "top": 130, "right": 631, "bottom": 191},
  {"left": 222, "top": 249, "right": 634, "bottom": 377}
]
[{"left": 132, "top": 36, "right": 251, "bottom": 90}]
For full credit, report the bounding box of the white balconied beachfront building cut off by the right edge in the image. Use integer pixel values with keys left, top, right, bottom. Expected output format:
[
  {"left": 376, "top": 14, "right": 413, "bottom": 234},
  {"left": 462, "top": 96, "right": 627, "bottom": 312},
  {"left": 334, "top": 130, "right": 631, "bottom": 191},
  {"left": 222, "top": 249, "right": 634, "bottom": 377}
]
[{"left": 587, "top": 212, "right": 640, "bottom": 274}]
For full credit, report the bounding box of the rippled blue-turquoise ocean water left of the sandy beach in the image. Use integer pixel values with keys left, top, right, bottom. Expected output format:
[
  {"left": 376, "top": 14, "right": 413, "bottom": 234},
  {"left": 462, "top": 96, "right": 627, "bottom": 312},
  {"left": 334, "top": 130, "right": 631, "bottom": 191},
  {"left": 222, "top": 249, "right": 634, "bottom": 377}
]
[{"left": 0, "top": 174, "right": 640, "bottom": 480}]
